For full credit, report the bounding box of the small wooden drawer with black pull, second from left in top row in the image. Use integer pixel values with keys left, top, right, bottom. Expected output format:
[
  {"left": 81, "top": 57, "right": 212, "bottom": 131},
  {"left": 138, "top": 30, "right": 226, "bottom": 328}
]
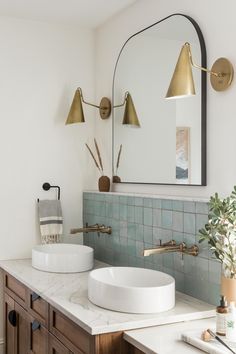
[{"left": 28, "top": 290, "right": 48, "bottom": 328}]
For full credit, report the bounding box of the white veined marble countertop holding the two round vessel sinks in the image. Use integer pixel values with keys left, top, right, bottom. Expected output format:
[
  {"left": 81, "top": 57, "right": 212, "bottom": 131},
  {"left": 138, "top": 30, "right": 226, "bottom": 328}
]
[{"left": 0, "top": 259, "right": 215, "bottom": 335}]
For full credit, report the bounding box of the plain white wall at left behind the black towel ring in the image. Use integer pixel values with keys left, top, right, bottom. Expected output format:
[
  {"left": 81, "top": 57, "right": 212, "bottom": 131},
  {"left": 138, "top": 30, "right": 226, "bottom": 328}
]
[{"left": 0, "top": 18, "right": 96, "bottom": 346}]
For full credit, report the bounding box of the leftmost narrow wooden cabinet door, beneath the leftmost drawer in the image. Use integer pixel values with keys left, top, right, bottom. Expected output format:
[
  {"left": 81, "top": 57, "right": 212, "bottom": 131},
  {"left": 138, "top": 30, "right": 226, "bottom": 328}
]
[{"left": 4, "top": 294, "right": 17, "bottom": 354}]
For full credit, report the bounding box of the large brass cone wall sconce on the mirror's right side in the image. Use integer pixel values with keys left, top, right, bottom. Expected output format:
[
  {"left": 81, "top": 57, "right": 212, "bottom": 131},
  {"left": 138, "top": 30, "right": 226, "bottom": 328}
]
[{"left": 166, "top": 43, "right": 234, "bottom": 98}]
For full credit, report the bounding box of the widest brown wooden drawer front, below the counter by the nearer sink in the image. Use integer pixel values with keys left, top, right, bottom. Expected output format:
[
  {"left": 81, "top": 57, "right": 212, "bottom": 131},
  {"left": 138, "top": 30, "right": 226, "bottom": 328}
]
[{"left": 49, "top": 306, "right": 95, "bottom": 354}]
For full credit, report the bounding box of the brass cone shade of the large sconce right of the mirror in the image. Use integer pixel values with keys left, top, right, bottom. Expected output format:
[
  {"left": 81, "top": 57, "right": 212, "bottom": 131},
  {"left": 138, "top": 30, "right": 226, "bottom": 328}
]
[{"left": 166, "top": 44, "right": 196, "bottom": 98}]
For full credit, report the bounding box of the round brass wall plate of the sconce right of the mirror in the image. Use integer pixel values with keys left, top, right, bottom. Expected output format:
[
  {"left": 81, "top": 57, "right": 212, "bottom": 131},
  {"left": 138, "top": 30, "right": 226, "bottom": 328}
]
[{"left": 210, "top": 58, "right": 234, "bottom": 91}]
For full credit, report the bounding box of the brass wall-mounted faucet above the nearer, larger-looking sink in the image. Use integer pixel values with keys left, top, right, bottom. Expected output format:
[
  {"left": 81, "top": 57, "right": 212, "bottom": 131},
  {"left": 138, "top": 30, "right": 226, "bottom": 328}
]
[{"left": 143, "top": 240, "right": 199, "bottom": 257}]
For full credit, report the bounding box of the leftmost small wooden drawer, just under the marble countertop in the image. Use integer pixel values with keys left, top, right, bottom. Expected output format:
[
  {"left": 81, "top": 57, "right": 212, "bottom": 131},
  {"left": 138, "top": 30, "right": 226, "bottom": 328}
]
[{"left": 4, "top": 272, "right": 27, "bottom": 307}]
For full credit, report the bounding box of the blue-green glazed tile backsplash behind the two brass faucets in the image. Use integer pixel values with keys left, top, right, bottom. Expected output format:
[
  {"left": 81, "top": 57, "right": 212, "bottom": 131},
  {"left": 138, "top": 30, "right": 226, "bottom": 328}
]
[{"left": 83, "top": 192, "right": 221, "bottom": 305}]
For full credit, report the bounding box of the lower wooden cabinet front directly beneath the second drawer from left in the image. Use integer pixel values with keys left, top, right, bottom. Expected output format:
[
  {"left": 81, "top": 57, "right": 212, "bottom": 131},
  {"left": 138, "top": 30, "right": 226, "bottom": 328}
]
[{"left": 28, "top": 316, "right": 48, "bottom": 354}]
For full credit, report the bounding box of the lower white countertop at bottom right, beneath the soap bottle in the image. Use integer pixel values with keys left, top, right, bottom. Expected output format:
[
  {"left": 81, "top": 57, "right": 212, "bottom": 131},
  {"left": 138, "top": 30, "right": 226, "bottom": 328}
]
[{"left": 124, "top": 318, "right": 217, "bottom": 354}]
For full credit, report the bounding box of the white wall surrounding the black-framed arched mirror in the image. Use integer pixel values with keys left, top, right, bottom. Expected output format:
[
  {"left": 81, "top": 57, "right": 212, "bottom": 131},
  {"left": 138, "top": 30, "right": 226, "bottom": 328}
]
[{"left": 96, "top": 0, "right": 236, "bottom": 198}]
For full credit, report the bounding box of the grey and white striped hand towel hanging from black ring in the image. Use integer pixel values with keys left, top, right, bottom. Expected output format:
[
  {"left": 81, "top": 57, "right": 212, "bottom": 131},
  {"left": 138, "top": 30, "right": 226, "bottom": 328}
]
[{"left": 38, "top": 200, "right": 63, "bottom": 243}]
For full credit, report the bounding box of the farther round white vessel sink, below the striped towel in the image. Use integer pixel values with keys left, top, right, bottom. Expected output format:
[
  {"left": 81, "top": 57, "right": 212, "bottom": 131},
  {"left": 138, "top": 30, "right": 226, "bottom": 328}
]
[{"left": 32, "top": 243, "right": 93, "bottom": 273}]
